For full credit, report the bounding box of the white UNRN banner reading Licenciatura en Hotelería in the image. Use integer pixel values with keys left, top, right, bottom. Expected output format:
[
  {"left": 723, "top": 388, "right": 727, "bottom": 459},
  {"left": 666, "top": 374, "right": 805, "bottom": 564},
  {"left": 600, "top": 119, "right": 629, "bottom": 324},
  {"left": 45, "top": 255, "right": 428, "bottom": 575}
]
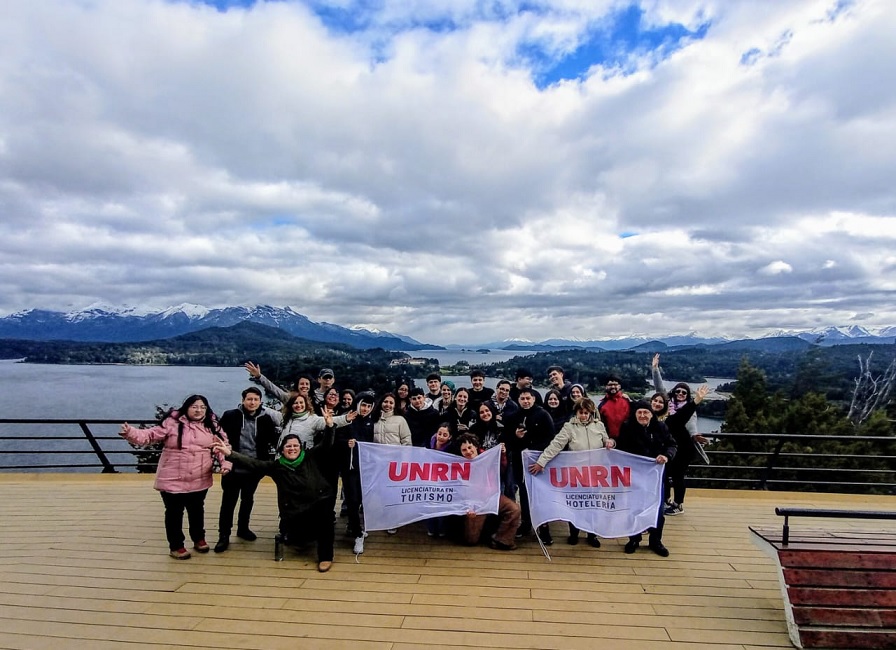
[{"left": 523, "top": 449, "right": 663, "bottom": 537}]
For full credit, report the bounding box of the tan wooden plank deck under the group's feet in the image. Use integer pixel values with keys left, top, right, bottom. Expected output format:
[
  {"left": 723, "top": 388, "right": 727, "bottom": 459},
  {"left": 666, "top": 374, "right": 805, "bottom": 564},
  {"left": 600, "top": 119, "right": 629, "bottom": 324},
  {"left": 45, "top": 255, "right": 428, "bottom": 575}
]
[{"left": 0, "top": 474, "right": 894, "bottom": 650}]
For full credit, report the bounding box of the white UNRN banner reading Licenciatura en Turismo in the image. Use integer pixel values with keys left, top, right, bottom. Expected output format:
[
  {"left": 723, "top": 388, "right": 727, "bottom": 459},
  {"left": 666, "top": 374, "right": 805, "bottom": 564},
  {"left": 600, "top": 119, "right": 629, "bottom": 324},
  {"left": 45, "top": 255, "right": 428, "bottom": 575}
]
[{"left": 358, "top": 442, "right": 501, "bottom": 530}]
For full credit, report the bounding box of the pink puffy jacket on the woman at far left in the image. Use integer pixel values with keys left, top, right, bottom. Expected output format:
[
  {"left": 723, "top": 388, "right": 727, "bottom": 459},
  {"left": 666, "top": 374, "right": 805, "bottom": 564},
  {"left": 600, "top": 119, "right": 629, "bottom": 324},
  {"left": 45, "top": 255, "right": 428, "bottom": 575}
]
[{"left": 121, "top": 411, "right": 232, "bottom": 493}]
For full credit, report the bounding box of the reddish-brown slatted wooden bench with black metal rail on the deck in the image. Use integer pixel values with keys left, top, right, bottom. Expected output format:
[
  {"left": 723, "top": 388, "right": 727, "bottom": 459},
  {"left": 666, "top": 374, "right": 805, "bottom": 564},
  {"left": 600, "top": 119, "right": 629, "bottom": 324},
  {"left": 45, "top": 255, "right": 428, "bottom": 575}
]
[{"left": 750, "top": 508, "right": 896, "bottom": 648}]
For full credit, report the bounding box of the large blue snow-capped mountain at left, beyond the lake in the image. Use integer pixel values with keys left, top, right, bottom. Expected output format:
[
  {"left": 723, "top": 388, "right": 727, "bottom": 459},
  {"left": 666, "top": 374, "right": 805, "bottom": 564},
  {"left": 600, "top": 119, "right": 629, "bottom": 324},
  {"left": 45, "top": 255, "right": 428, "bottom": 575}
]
[{"left": 0, "top": 303, "right": 438, "bottom": 350}]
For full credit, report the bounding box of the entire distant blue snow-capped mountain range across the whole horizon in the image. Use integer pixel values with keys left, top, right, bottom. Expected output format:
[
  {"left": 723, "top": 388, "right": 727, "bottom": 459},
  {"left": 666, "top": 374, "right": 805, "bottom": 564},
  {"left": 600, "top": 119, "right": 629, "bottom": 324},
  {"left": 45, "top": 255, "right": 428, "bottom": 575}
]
[{"left": 0, "top": 304, "right": 896, "bottom": 352}]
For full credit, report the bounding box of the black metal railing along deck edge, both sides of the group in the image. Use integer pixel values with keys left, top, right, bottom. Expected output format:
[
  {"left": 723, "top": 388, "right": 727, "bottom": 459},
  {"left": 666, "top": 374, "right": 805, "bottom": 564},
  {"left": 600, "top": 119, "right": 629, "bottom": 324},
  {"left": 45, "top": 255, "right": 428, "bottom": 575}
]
[{"left": 0, "top": 418, "right": 896, "bottom": 494}]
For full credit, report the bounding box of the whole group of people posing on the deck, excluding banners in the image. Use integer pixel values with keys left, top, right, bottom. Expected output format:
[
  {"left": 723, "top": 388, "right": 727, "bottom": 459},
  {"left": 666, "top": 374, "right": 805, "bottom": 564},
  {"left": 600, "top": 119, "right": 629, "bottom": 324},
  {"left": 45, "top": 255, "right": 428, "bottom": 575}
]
[{"left": 120, "top": 355, "right": 708, "bottom": 572}]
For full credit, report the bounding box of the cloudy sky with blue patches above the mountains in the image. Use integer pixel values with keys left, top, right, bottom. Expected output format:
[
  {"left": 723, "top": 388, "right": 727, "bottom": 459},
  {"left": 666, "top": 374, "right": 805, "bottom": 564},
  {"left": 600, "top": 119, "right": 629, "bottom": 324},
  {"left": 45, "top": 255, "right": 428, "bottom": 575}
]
[{"left": 0, "top": 0, "right": 896, "bottom": 343}]
